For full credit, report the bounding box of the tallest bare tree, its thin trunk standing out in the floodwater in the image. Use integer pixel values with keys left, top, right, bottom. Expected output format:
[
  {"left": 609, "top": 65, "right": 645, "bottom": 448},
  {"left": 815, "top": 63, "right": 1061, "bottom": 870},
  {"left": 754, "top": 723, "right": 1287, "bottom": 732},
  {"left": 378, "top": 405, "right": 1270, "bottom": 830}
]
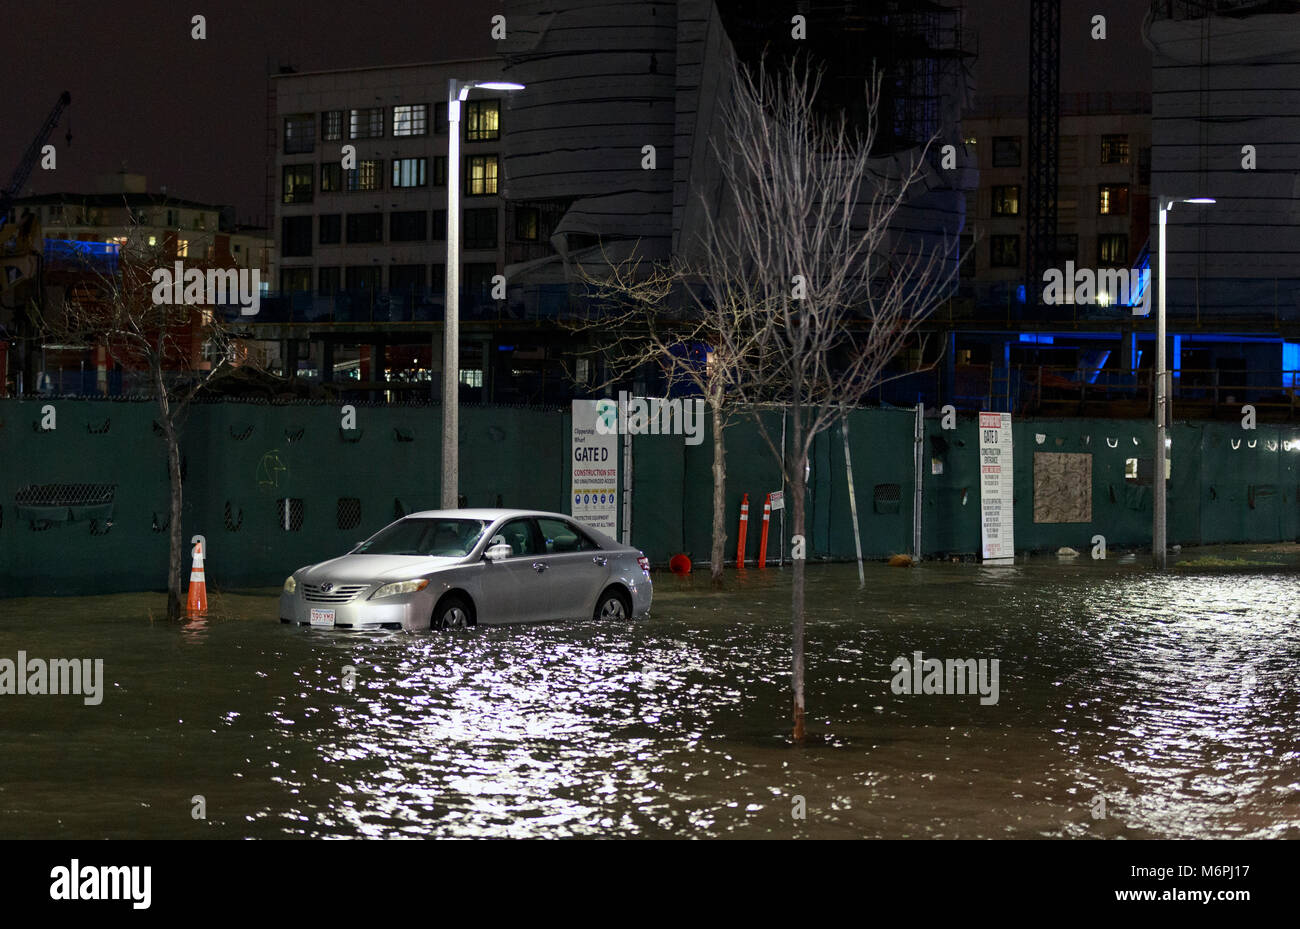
[{"left": 701, "top": 64, "right": 957, "bottom": 741}]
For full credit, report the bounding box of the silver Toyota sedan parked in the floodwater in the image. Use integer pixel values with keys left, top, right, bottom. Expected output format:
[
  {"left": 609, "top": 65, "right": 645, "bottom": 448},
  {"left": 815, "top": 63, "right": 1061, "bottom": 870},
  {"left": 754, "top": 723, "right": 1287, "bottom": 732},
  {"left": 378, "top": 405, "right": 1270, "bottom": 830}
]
[{"left": 280, "top": 509, "right": 651, "bottom": 629}]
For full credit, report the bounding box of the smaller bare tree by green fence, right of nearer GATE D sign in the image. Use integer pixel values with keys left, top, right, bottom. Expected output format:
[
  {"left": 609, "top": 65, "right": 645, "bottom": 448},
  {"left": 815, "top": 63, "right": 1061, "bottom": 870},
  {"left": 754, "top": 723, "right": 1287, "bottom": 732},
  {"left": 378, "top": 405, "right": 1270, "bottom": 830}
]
[{"left": 577, "top": 249, "right": 759, "bottom": 587}]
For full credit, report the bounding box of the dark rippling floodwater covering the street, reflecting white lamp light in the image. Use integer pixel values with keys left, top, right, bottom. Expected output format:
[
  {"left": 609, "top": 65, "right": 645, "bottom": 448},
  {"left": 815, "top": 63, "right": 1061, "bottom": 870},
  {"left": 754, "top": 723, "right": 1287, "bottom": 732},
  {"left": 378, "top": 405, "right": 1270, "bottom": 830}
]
[{"left": 0, "top": 550, "right": 1300, "bottom": 838}]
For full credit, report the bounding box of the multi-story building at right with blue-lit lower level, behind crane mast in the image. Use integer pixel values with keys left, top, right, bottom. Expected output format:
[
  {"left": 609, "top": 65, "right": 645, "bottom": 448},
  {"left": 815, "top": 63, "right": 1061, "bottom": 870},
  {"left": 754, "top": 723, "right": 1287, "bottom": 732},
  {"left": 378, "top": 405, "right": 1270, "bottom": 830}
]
[{"left": 937, "top": 92, "right": 1152, "bottom": 409}]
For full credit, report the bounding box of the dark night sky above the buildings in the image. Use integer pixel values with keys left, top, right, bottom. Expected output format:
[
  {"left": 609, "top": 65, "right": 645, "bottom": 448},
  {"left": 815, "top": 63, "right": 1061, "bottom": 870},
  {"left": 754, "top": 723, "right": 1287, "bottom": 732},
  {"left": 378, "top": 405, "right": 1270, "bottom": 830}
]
[{"left": 0, "top": 0, "right": 1151, "bottom": 221}]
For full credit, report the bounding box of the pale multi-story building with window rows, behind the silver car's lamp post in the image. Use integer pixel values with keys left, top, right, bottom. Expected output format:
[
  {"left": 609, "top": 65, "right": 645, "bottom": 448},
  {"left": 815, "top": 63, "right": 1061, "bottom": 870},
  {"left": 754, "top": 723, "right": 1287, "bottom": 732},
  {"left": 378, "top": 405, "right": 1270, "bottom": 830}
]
[{"left": 267, "top": 58, "right": 507, "bottom": 396}]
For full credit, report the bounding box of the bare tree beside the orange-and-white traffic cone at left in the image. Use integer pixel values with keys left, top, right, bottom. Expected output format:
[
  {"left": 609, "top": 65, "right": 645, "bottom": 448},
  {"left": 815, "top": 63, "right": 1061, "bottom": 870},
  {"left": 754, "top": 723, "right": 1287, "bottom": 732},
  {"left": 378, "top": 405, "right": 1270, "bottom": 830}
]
[{"left": 46, "top": 227, "right": 250, "bottom": 618}]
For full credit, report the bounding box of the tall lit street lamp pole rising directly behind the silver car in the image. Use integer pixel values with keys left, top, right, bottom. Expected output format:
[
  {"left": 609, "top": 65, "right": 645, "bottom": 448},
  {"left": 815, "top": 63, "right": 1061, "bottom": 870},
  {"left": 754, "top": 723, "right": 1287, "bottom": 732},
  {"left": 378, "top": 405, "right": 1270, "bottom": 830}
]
[{"left": 442, "top": 78, "right": 524, "bottom": 509}]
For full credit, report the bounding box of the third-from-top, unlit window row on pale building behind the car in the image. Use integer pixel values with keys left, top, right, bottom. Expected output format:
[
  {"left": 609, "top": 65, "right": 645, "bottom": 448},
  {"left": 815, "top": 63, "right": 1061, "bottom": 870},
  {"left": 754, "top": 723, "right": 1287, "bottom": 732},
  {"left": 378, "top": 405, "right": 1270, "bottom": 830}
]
[{"left": 280, "top": 208, "right": 498, "bottom": 259}]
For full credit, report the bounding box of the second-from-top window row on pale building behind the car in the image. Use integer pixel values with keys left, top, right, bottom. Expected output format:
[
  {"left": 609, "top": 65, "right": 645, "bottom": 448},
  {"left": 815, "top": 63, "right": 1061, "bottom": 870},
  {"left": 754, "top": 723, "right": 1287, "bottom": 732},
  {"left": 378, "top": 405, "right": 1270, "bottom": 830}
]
[{"left": 280, "top": 155, "right": 499, "bottom": 204}]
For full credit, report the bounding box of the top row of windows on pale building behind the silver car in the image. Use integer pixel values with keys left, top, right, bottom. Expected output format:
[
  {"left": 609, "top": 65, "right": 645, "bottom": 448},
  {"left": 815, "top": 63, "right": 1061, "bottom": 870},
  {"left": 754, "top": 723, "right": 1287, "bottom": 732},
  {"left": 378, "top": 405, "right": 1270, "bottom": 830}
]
[{"left": 283, "top": 100, "right": 501, "bottom": 155}]
